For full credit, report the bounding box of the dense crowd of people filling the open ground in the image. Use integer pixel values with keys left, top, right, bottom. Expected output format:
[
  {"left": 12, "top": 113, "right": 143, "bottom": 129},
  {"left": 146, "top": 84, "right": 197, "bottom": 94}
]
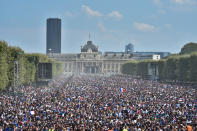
[{"left": 0, "top": 75, "right": 197, "bottom": 131}]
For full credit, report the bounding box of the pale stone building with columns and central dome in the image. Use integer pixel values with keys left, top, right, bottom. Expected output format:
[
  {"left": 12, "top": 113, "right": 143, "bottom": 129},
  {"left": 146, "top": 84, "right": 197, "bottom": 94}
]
[{"left": 48, "top": 41, "right": 133, "bottom": 74}]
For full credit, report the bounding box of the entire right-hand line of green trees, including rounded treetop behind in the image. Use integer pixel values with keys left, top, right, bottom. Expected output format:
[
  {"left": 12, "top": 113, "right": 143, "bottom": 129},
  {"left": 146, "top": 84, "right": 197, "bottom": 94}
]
[{"left": 122, "top": 43, "right": 197, "bottom": 82}]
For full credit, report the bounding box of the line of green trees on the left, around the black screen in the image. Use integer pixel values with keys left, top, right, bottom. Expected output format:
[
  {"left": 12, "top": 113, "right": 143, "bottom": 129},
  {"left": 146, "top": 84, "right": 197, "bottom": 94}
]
[{"left": 0, "top": 41, "right": 63, "bottom": 90}]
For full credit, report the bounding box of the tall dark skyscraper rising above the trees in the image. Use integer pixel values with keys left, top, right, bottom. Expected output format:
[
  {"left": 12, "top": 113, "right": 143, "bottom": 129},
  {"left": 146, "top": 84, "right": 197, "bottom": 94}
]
[{"left": 46, "top": 18, "right": 61, "bottom": 54}]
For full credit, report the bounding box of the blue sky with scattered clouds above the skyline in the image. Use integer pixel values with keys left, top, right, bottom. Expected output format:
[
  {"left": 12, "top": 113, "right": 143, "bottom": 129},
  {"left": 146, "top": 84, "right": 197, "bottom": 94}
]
[{"left": 0, "top": 0, "right": 197, "bottom": 53}]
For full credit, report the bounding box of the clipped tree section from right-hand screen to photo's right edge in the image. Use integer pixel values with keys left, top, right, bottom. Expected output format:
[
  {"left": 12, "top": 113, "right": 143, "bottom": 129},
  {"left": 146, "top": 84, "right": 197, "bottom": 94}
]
[{"left": 158, "top": 53, "right": 197, "bottom": 82}]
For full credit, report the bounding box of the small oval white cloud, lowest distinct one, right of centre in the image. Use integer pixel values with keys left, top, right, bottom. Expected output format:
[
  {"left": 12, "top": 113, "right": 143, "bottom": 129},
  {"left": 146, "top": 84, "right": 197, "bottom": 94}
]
[{"left": 133, "top": 22, "right": 156, "bottom": 32}]
